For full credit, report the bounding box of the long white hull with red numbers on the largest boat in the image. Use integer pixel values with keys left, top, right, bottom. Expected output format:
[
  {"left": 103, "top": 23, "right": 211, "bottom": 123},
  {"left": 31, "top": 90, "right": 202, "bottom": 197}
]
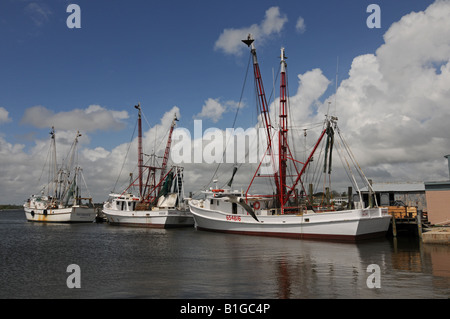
[{"left": 189, "top": 201, "right": 391, "bottom": 241}]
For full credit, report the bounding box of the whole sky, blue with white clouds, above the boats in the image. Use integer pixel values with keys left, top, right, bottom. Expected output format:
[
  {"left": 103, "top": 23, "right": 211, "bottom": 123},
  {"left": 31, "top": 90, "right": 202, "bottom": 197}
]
[{"left": 0, "top": 0, "right": 450, "bottom": 204}]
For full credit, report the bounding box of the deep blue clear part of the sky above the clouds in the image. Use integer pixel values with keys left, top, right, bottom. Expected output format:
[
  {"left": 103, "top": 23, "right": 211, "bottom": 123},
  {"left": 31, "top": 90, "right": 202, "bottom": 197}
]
[{"left": 0, "top": 0, "right": 450, "bottom": 205}]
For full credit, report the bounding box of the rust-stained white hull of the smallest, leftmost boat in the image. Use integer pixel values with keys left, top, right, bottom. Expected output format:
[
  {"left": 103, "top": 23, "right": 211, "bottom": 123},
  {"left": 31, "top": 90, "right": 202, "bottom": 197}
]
[{"left": 24, "top": 206, "right": 97, "bottom": 223}]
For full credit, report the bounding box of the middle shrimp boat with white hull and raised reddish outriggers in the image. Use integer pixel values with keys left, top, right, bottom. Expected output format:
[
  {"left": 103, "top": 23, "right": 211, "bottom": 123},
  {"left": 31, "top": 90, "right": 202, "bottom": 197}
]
[{"left": 103, "top": 104, "right": 194, "bottom": 228}]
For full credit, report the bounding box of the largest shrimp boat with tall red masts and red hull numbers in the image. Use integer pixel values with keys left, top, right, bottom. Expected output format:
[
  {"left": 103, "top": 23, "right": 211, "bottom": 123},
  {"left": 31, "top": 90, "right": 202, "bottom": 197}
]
[{"left": 189, "top": 35, "right": 391, "bottom": 241}]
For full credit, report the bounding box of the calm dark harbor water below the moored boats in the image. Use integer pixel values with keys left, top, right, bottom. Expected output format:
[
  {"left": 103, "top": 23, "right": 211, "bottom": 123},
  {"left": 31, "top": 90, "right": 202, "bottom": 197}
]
[{"left": 0, "top": 210, "right": 450, "bottom": 299}]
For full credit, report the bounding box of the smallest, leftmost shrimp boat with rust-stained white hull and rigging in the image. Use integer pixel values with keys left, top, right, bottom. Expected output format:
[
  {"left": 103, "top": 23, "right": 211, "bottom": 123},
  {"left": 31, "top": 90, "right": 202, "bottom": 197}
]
[{"left": 23, "top": 128, "right": 97, "bottom": 223}]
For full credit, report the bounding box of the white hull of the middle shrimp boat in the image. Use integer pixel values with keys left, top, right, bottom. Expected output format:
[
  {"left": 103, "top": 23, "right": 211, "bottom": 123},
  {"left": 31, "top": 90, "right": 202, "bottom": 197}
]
[{"left": 103, "top": 208, "right": 194, "bottom": 228}]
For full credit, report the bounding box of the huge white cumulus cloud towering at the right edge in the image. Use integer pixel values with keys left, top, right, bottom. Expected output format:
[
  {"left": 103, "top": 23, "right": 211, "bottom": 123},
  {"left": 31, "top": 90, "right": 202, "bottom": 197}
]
[{"left": 284, "top": 1, "right": 450, "bottom": 181}]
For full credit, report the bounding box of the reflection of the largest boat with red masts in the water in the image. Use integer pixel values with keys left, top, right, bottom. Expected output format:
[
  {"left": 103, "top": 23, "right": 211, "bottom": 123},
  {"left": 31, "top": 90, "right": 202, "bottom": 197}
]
[{"left": 227, "top": 236, "right": 392, "bottom": 299}]
